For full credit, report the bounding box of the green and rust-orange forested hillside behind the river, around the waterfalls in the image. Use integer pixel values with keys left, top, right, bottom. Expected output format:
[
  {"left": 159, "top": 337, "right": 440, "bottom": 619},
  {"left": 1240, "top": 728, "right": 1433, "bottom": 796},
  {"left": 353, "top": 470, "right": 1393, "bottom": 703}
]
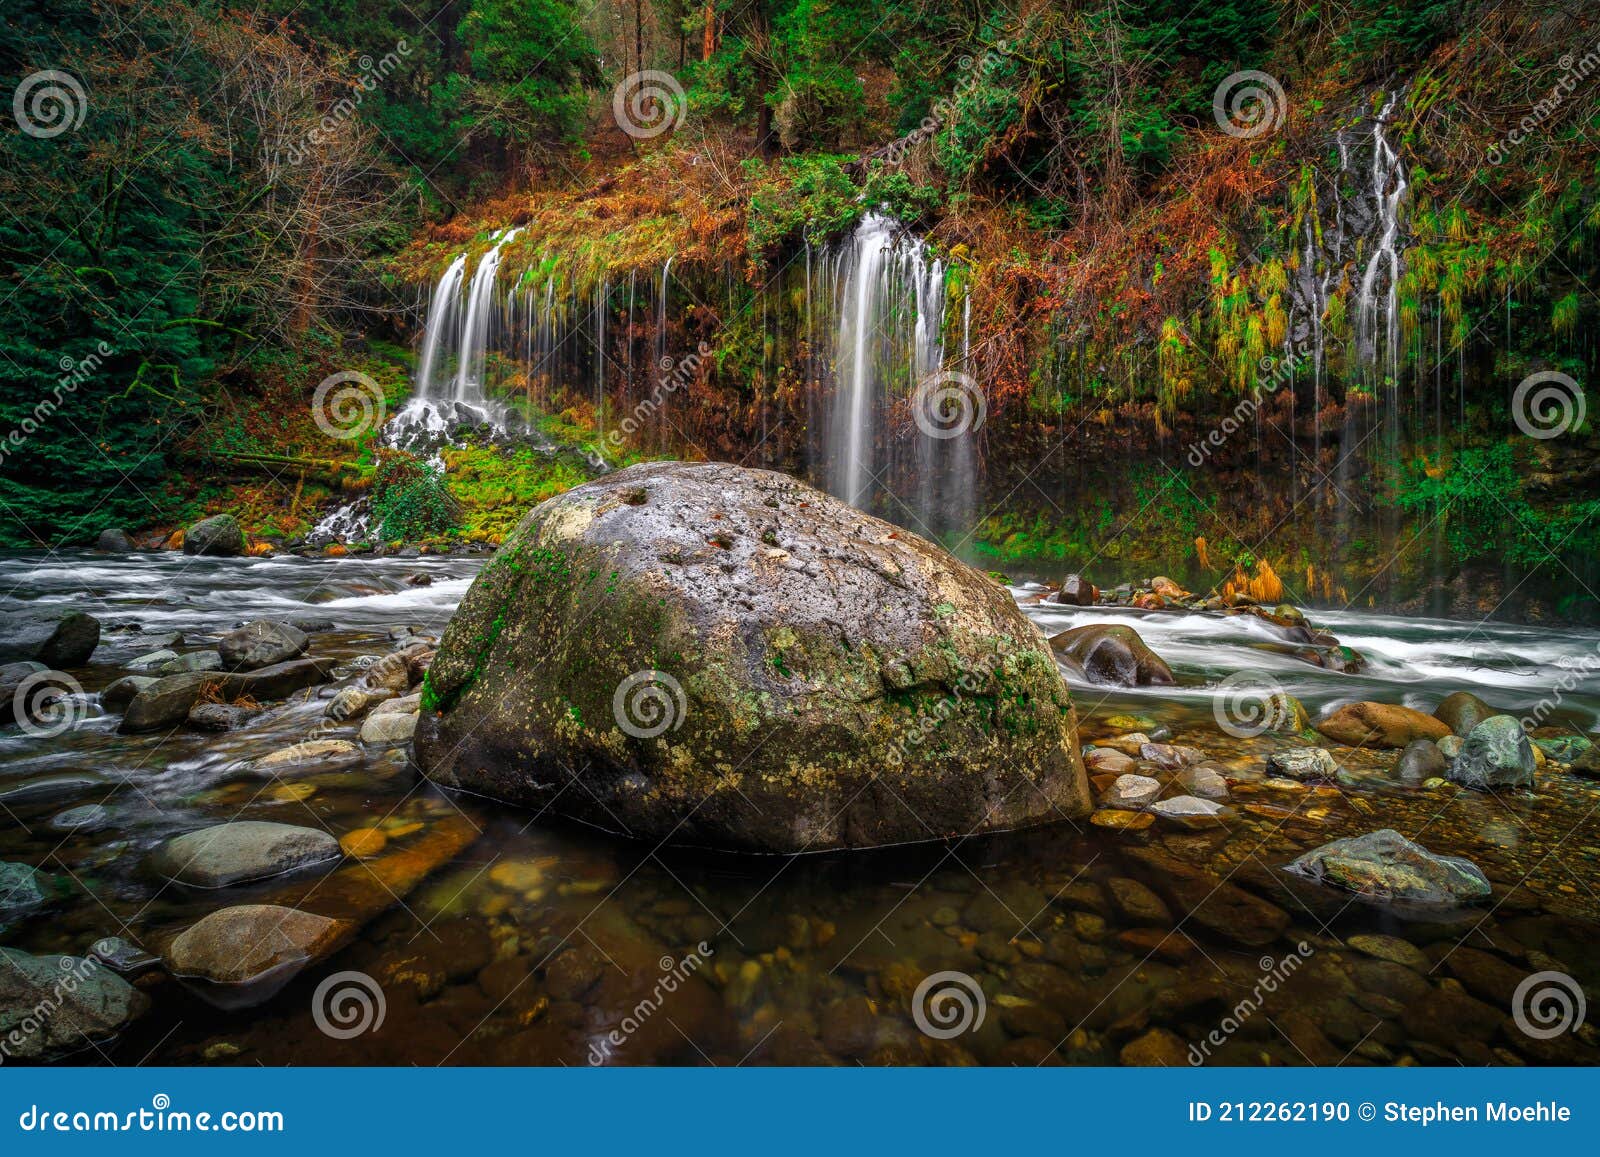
[{"left": 0, "top": 0, "right": 1600, "bottom": 610}]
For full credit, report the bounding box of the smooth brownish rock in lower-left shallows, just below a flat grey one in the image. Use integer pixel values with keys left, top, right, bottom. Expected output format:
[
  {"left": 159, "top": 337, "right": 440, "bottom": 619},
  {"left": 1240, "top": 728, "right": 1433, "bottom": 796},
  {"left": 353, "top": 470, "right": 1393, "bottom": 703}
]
[{"left": 163, "top": 904, "right": 344, "bottom": 999}]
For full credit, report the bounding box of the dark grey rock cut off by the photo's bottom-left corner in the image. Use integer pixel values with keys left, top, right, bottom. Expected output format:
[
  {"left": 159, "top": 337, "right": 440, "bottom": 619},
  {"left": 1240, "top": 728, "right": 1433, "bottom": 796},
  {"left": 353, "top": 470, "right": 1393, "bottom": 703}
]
[{"left": 0, "top": 947, "right": 150, "bottom": 1061}]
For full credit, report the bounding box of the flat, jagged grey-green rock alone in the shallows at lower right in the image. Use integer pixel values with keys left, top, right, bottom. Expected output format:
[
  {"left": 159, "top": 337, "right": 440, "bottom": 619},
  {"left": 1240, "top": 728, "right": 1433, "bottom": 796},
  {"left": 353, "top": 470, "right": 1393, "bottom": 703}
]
[{"left": 1288, "top": 827, "right": 1490, "bottom": 906}]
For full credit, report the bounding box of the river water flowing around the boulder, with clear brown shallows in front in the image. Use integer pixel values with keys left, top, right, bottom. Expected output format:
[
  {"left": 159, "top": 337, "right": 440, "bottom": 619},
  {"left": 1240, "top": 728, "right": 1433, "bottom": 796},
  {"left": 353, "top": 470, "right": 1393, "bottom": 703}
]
[{"left": 0, "top": 554, "right": 1600, "bottom": 1064}]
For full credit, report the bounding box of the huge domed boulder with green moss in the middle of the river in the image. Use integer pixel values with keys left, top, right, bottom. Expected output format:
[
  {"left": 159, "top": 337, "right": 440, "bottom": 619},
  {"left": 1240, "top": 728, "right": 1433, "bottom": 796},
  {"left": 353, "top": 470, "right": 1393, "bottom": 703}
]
[{"left": 416, "top": 462, "right": 1088, "bottom": 851}]
